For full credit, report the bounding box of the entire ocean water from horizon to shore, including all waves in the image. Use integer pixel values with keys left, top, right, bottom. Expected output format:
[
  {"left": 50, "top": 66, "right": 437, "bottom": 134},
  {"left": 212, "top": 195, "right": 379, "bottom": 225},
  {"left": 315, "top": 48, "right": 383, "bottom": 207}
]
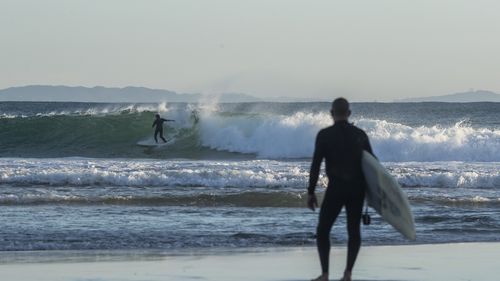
[{"left": 0, "top": 102, "right": 500, "bottom": 251}]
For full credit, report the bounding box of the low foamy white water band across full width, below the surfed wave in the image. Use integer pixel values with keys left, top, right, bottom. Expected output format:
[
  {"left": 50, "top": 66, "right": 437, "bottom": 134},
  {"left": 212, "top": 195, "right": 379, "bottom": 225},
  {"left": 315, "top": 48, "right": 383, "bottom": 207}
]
[{"left": 0, "top": 158, "right": 500, "bottom": 190}]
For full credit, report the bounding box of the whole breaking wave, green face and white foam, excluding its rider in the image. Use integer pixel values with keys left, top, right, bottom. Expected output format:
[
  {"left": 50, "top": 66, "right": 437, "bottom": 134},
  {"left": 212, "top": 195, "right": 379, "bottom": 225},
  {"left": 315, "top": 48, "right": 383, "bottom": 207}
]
[{"left": 0, "top": 101, "right": 500, "bottom": 162}]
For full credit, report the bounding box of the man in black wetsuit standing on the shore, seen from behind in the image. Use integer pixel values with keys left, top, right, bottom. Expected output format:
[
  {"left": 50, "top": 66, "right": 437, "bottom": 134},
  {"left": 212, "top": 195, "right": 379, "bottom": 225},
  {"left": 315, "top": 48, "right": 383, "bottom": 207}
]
[{"left": 307, "top": 98, "right": 372, "bottom": 281}]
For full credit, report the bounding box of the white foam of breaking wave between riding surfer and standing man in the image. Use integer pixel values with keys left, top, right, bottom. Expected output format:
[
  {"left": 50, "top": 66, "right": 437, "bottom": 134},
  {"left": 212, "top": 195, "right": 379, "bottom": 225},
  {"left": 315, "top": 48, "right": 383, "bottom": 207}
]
[{"left": 200, "top": 112, "right": 331, "bottom": 158}]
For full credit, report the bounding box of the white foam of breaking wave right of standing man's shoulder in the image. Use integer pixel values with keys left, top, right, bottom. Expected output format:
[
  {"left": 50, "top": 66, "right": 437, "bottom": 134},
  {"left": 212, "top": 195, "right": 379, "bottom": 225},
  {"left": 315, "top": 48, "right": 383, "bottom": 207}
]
[{"left": 358, "top": 119, "right": 500, "bottom": 162}]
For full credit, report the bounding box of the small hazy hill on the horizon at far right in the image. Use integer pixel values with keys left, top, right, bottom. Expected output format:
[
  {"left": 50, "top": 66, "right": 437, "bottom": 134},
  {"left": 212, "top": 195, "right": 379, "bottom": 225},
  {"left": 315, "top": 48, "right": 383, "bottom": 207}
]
[{"left": 397, "top": 90, "right": 500, "bottom": 102}]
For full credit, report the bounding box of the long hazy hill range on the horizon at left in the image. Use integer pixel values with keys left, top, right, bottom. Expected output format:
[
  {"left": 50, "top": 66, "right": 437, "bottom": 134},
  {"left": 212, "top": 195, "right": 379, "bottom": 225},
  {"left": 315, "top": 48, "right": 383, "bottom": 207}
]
[{"left": 0, "top": 85, "right": 260, "bottom": 103}]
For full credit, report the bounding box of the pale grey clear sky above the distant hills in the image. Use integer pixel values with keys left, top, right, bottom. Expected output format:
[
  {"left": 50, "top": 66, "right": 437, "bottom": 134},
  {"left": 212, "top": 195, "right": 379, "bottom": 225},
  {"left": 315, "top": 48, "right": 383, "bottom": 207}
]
[{"left": 0, "top": 0, "right": 500, "bottom": 101}]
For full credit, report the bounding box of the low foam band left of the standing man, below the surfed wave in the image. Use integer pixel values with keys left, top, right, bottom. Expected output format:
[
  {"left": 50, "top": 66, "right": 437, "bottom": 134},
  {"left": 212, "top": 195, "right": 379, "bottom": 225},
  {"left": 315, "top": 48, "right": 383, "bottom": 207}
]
[{"left": 0, "top": 159, "right": 316, "bottom": 187}]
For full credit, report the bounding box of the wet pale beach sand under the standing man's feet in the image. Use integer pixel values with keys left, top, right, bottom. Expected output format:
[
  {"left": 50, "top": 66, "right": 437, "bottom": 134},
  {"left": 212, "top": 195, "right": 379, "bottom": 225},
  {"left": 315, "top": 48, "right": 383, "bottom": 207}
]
[{"left": 0, "top": 243, "right": 500, "bottom": 281}]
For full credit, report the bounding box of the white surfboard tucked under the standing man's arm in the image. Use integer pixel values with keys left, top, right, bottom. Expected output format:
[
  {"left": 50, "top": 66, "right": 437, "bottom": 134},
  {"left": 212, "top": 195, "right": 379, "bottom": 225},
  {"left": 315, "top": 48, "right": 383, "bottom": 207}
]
[{"left": 361, "top": 151, "right": 416, "bottom": 240}]
